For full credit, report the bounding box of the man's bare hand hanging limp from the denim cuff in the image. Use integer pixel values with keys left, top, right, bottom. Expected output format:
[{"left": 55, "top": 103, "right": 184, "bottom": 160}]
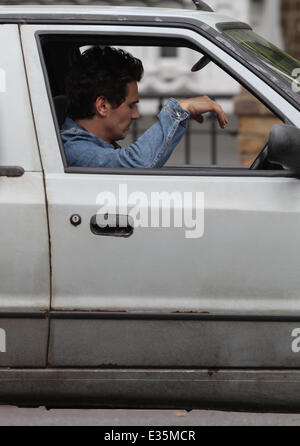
[{"left": 178, "top": 96, "right": 228, "bottom": 129}]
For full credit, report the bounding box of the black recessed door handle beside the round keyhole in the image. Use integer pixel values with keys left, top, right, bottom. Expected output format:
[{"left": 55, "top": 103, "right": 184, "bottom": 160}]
[{"left": 90, "top": 214, "right": 134, "bottom": 237}]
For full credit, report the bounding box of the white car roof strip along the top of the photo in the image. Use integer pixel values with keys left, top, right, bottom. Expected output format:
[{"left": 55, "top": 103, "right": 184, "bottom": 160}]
[{"left": 0, "top": 5, "right": 238, "bottom": 31}]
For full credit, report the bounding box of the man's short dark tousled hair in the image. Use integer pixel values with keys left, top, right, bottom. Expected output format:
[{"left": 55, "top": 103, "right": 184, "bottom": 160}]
[{"left": 66, "top": 46, "right": 144, "bottom": 120}]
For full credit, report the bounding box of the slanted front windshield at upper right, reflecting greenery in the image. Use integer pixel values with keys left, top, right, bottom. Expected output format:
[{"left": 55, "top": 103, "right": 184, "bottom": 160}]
[{"left": 224, "top": 29, "right": 300, "bottom": 101}]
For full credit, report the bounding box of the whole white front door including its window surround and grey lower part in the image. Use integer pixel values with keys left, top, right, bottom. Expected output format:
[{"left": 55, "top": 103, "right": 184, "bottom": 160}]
[{"left": 21, "top": 20, "right": 300, "bottom": 367}]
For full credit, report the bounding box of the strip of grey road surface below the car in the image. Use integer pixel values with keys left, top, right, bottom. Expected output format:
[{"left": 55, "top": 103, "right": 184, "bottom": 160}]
[{"left": 0, "top": 406, "right": 300, "bottom": 426}]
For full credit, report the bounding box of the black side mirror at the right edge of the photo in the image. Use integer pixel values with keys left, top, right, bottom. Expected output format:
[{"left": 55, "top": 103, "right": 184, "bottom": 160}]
[{"left": 268, "top": 124, "right": 300, "bottom": 170}]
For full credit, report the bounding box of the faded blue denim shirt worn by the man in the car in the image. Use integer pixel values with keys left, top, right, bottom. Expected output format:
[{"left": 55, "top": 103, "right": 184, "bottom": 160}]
[{"left": 61, "top": 98, "right": 190, "bottom": 168}]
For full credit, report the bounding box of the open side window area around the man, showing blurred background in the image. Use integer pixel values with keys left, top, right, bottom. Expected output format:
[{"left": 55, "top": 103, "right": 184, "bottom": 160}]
[{"left": 43, "top": 37, "right": 281, "bottom": 172}]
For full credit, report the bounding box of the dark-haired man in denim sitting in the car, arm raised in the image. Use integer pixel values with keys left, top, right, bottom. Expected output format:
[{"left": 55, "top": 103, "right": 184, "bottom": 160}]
[{"left": 61, "top": 47, "right": 227, "bottom": 168}]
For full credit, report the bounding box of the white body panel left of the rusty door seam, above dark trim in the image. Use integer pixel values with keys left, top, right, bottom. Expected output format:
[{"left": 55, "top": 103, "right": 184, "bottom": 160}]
[{"left": 0, "top": 172, "right": 50, "bottom": 311}]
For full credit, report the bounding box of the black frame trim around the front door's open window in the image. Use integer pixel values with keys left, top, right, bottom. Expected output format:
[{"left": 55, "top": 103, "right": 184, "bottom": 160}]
[{"left": 35, "top": 23, "right": 299, "bottom": 178}]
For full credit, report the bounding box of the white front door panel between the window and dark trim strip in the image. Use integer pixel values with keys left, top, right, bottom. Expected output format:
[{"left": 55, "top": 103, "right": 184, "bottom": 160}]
[{"left": 43, "top": 174, "right": 300, "bottom": 314}]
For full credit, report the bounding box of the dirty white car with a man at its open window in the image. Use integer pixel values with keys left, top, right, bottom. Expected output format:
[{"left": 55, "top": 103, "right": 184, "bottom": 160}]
[{"left": 0, "top": 0, "right": 300, "bottom": 411}]
